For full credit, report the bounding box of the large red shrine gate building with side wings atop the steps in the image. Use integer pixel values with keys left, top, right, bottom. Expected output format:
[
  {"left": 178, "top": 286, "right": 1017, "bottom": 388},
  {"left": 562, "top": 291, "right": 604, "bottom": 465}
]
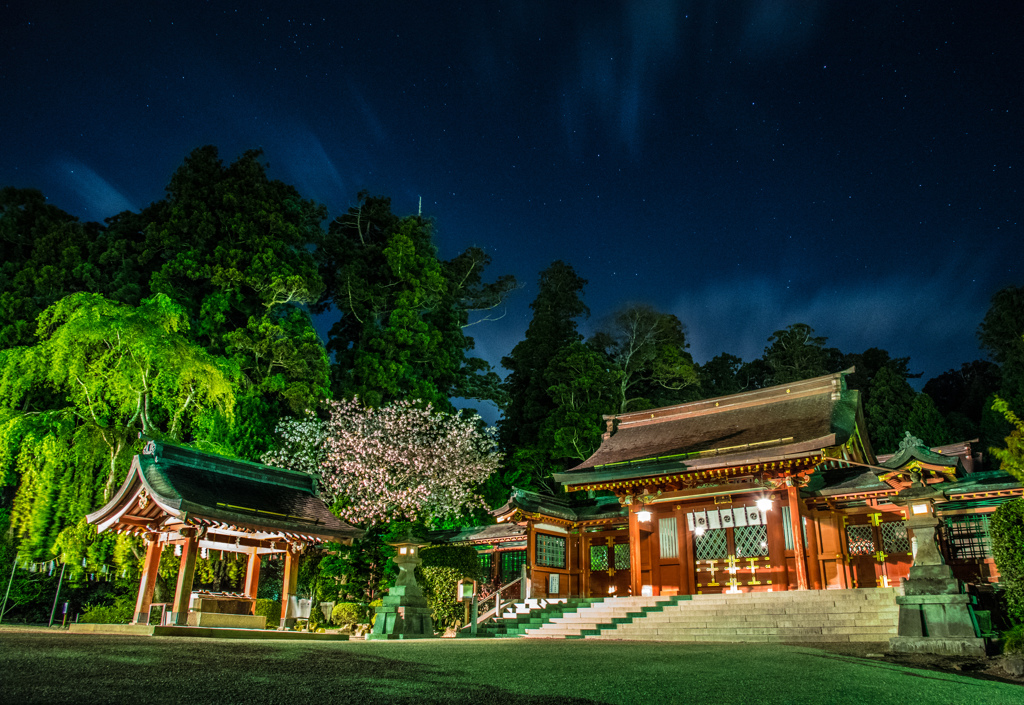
[{"left": 435, "top": 369, "right": 1024, "bottom": 597}]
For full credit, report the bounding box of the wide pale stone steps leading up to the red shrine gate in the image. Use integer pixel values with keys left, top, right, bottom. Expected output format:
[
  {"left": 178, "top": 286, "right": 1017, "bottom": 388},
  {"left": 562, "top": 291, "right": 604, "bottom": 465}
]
[{"left": 501, "top": 588, "right": 900, "bottom": 642}]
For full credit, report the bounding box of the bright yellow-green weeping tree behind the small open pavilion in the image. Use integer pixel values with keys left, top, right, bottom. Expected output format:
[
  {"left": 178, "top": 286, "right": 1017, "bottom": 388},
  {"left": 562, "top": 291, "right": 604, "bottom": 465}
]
[{"left": 0, "top": 293, "right": 239, "bottom": 566}]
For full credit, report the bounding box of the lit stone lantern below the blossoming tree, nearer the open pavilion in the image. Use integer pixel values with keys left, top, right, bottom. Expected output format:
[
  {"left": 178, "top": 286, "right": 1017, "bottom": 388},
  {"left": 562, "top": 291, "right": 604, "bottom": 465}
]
[{"left": 367, "top": 531, "right": 434, "bottom": 639}]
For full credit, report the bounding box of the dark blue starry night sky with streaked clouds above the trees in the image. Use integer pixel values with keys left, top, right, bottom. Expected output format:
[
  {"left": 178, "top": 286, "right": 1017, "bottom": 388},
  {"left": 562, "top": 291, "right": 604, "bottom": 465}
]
[{"left": 0, "top": 0, "right": 1024, "bottom": 418}]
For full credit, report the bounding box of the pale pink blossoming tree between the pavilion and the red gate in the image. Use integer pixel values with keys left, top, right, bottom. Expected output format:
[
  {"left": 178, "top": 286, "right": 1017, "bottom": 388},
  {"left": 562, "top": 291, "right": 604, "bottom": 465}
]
[{"left": 263, "top": 399, "right": 501, "bottom": 525}]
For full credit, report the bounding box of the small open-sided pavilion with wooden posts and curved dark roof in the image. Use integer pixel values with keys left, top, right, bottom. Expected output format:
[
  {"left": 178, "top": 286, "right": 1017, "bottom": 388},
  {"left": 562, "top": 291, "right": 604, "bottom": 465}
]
[{"left": 87, "top": 441, "right": 362, "bottom": 628}]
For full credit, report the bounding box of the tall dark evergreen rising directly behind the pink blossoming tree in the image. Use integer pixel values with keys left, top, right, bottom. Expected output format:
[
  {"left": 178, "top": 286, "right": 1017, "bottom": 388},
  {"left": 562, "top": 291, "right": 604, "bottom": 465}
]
[{"left": 315, "top": 192, "right": 515, "bottom": 410}]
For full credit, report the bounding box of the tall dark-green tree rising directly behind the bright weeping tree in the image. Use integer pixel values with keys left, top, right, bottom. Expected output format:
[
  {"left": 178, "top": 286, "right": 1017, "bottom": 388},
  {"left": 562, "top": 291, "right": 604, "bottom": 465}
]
[{"left": 139, "top": 147, "right": 329, "bottom": 459}]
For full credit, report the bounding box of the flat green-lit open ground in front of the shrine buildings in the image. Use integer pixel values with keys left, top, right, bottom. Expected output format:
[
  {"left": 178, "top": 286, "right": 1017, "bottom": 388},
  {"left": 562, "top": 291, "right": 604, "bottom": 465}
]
[{"left": 0, "top": 629, "right": 1024, "bottom": 705}]
